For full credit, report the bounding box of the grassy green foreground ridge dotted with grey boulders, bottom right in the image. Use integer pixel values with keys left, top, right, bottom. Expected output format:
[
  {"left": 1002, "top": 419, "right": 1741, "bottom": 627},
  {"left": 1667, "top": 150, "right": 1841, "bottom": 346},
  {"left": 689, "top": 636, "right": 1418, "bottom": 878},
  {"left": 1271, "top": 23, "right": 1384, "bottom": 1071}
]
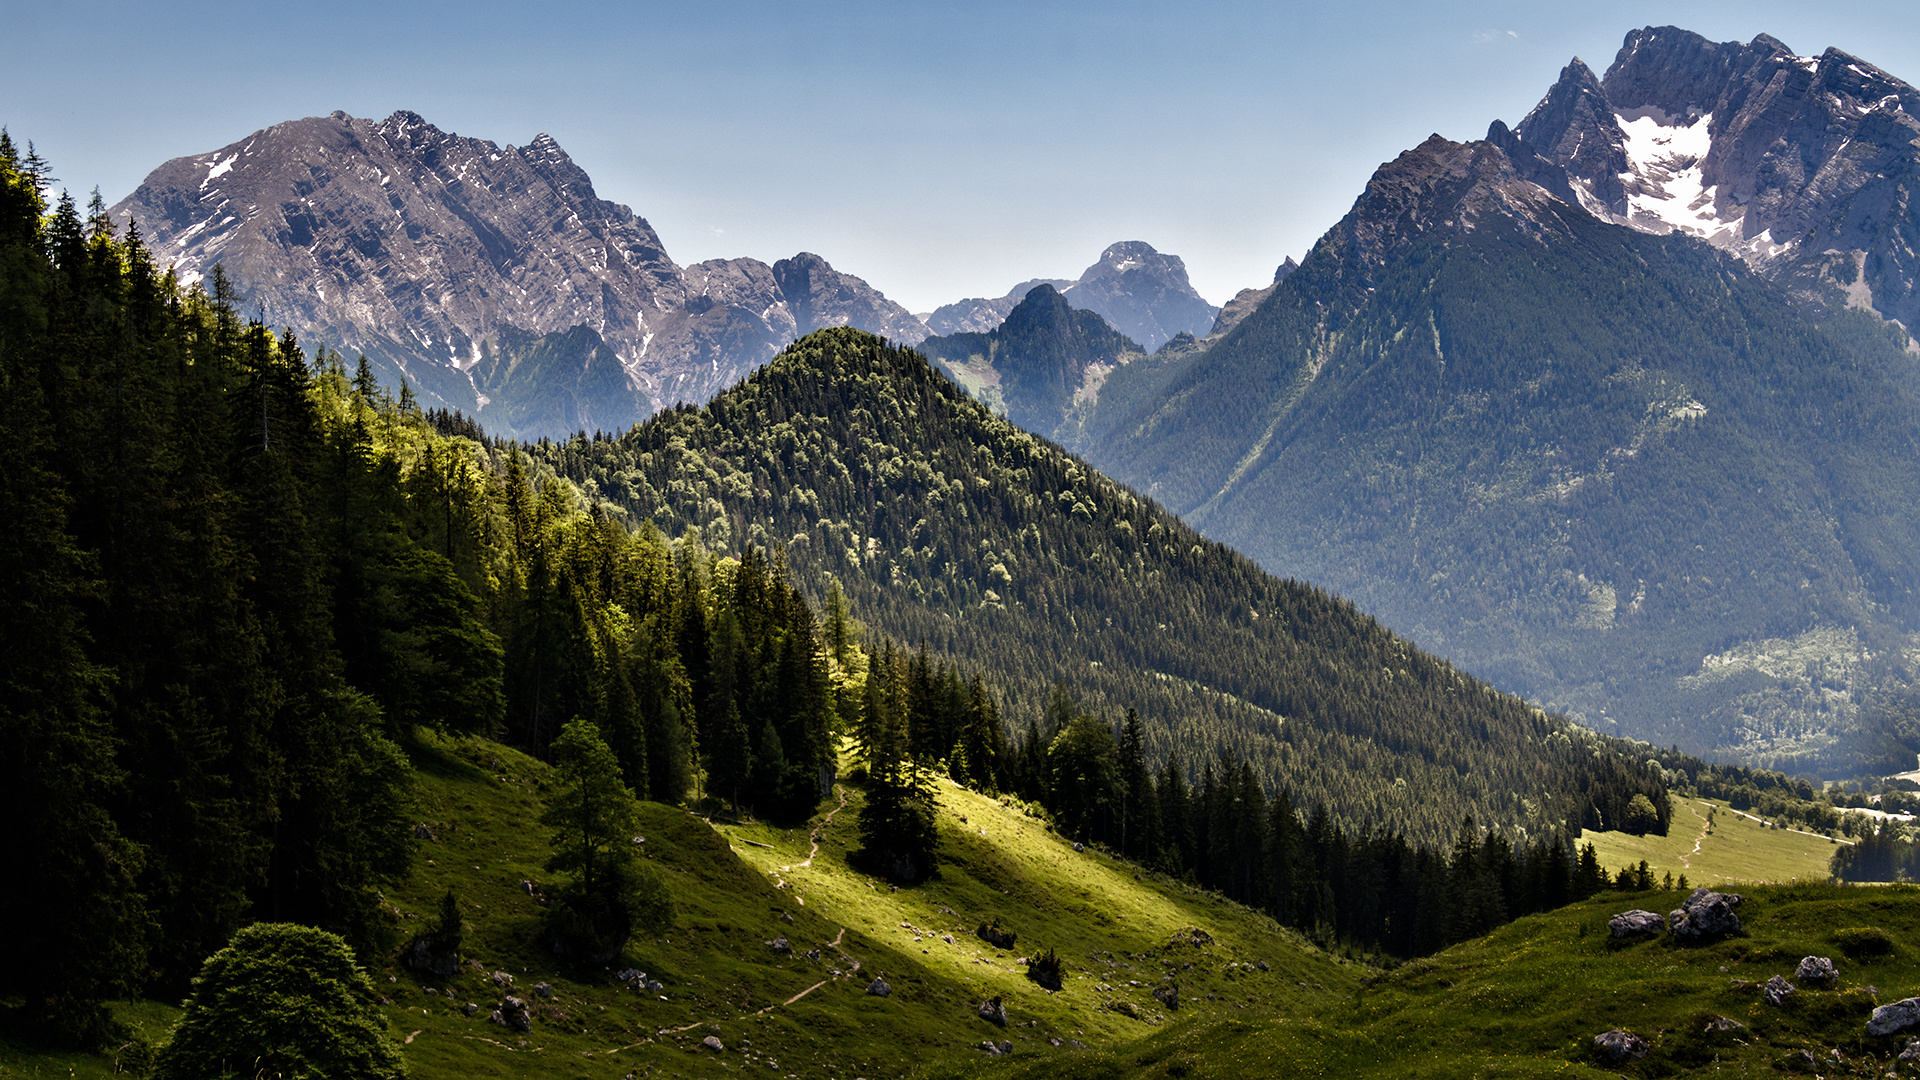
[{"left": 927, "top": 886, "right": 1920, "bottom": 1080}]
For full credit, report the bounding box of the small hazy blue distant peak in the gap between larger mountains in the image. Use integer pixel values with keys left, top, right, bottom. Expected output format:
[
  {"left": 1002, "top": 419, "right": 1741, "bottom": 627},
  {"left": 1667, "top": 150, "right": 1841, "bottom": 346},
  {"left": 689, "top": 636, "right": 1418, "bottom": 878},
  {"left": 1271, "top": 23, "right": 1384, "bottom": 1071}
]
[{"left": 927, "top": 240, "right": 1213, "bottom": 352}]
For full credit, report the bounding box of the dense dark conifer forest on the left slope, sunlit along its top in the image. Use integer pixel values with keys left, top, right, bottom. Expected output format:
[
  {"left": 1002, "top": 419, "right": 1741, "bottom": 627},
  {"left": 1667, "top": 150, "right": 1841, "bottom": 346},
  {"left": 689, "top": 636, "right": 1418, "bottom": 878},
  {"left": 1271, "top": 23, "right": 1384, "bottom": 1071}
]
[{"left": 0, "top": 136, "right": 848, "bottom": 1042}]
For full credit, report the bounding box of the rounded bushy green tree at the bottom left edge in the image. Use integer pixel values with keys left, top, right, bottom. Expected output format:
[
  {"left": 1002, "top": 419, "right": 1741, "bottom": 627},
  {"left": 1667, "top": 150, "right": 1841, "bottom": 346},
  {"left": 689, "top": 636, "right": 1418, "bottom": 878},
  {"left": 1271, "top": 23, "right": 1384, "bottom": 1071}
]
[{"left": 154, "top": 922, "right": 407, "bottom": 1080}]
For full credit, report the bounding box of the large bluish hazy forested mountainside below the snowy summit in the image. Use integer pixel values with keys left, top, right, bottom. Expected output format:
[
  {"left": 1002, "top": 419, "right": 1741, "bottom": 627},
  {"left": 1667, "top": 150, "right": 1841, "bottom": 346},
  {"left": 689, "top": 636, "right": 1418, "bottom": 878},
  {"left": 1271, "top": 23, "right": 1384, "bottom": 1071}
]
[{"left": 1091, "top": 123, "right": 1920, "bottom": 774}]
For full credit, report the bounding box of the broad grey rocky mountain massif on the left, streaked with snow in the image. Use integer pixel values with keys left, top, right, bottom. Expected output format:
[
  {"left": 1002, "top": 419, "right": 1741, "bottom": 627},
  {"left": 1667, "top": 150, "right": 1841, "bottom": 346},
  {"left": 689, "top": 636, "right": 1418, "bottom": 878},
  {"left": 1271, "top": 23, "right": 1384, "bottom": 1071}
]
[{"left": 113, "top": 111, "right": 925, "bottom": 436}]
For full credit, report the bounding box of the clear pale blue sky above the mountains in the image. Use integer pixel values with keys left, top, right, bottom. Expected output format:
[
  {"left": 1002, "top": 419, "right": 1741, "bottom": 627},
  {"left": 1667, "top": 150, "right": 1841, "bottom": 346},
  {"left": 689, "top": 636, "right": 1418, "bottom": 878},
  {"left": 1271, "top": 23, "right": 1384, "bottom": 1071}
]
[{"left": 0, "top": 0, "right": 1920, "bottom": 311}]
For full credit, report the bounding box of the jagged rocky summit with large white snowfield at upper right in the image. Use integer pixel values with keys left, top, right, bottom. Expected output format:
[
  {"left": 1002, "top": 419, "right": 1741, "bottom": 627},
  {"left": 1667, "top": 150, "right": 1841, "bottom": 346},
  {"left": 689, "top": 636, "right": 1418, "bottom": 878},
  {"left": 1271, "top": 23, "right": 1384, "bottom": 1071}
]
[{"left": 1517, "top": 27, "right": 1920, "bottom": 327}]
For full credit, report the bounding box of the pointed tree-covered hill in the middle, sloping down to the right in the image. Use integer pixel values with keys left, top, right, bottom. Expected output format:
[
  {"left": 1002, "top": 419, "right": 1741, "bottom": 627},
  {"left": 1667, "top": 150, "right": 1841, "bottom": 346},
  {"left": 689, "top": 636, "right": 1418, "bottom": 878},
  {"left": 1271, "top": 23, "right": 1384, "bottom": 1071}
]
[{"left": 528, "top": 331, "right": 1647, "bottom": 838}]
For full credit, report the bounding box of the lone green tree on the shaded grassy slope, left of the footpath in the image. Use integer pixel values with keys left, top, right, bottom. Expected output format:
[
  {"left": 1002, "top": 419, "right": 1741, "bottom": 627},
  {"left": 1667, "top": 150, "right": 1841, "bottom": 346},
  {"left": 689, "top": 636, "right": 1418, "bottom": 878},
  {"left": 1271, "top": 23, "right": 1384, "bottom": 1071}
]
[{"left": 540, "top": 717, "right": 674, "bottom": 949}]
